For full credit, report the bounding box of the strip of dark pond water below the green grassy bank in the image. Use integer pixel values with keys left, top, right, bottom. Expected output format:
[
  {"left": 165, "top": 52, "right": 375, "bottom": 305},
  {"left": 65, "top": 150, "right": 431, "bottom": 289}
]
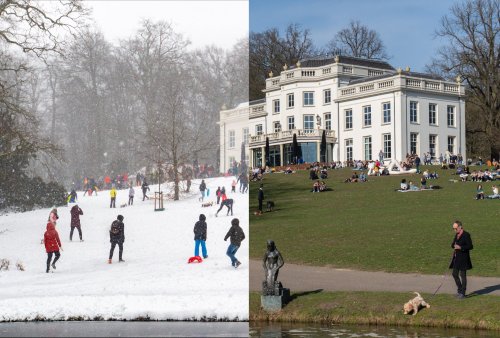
[{"left": 250, "top": 322, "right": 500, "bottom": 338}]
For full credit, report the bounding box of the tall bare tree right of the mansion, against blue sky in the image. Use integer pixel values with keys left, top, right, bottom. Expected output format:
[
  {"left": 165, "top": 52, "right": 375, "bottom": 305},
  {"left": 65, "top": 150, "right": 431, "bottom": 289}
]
[{"left": 428, "top": 0, "right": 500, "bottom": 156}]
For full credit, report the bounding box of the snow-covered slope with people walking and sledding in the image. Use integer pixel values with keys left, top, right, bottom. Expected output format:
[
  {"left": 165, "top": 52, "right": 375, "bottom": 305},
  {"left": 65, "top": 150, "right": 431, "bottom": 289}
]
[{"left": 0, "top": 177, "right": 249, "bottom": 321}]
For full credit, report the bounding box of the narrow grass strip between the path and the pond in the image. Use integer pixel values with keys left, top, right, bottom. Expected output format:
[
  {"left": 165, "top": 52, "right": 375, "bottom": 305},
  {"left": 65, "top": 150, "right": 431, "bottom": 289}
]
[{"left": 250, "top": 292, "right": 500, "bottom": 330}]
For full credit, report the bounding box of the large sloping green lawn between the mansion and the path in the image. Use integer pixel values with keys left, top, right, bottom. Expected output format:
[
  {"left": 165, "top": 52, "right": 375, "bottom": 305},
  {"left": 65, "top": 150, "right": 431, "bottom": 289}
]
[{"left": 250, "top": 166, "right": 500, "bottom": 276}]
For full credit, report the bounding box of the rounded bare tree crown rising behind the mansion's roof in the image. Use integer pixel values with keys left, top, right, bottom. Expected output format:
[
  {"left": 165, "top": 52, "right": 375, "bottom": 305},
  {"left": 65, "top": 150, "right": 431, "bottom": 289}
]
[{"left": 327, "top": 21, "right": 389, "bottom": 60}]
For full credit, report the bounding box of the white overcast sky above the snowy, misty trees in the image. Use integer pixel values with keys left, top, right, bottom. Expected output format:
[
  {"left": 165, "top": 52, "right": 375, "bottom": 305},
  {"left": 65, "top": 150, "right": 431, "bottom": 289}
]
[{"left": 85, "top": 0, "right": 249, "bottom": 49}]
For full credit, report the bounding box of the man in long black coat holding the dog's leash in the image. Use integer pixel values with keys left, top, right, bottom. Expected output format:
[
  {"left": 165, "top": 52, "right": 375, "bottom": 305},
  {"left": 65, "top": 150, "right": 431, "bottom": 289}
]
[{"left": 450, "top": 221, "right": 473, "bottom": 299}]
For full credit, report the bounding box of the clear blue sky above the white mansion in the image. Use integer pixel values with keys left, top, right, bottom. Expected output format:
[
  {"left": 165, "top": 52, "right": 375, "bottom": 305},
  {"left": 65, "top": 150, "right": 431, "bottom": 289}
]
[{"left": 250, "top": 0, "right": 460, "bottom": 72}]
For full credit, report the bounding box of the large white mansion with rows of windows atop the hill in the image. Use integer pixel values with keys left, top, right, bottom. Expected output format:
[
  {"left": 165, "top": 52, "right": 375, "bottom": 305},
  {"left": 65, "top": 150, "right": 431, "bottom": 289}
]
[{"left": 219, "top": 56, "right": 466, "bottom": 172}]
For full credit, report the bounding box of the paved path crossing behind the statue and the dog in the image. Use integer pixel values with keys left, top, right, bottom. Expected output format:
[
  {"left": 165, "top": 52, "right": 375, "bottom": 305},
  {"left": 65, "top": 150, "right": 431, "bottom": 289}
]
[{"left": 250, "top": 260, "right": 500, "bottom": 296}]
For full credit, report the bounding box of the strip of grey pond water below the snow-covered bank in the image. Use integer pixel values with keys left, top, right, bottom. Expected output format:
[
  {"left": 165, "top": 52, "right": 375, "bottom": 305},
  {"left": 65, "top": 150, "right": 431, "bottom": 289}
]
[{"left": 0, "top": 321, "right": 248, "bottom": 337}]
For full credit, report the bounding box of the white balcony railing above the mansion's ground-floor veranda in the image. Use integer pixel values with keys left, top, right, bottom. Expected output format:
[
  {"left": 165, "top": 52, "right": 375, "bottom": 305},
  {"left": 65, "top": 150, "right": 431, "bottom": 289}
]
[{"left": 250, "top": 129, "right": 335, "bottom": 145}]
